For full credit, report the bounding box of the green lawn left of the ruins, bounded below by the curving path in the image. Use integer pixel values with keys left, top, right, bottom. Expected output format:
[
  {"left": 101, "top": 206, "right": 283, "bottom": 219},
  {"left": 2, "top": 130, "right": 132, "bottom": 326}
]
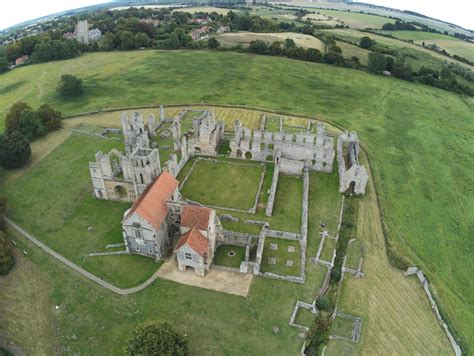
[{"left": 0, "top": 134, "right": 158, "bottom": 287}]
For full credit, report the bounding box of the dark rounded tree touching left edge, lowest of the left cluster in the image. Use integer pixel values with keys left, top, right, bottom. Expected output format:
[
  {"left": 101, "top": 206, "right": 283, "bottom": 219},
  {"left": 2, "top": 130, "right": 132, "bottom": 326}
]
[{"left": 0, "top": 131, "right": 31, "bottom": 169}]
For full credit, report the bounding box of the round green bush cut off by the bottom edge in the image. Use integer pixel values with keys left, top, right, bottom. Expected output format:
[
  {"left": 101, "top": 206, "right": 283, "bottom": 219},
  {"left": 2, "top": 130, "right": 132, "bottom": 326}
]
[{"left": 127, "top": 323, "right": 189, "bottom": 356}]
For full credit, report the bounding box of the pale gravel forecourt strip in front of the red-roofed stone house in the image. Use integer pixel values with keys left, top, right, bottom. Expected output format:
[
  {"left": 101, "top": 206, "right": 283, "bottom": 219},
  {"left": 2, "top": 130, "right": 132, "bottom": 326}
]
[{"left": 158, "top": 258, "right": 253, "bottom": 297}]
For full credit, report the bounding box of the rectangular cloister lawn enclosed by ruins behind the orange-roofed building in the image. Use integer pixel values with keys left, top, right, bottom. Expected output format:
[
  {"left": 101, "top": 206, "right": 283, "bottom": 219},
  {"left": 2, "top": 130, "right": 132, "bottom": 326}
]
[{"left": 181, "top": 160, "right": 262, "bottom": 210}]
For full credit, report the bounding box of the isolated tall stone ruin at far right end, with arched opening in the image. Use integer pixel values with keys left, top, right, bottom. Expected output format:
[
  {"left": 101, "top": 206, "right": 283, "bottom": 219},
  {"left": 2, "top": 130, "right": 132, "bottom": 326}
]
[{"left": 337, "top": 131, "right": 369, "bottom": 195}]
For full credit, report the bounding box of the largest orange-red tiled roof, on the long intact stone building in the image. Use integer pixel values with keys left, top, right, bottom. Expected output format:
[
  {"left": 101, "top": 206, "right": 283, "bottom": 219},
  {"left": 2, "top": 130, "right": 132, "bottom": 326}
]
[{"left": 127, "top": 171, "right": 178, "bottom": 229}]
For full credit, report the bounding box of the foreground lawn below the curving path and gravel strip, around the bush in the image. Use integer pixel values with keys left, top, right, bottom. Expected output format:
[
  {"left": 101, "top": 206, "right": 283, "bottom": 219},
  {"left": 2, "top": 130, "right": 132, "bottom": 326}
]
[{"left": 0, "top": 157, "right": 334, "bottom": 355}]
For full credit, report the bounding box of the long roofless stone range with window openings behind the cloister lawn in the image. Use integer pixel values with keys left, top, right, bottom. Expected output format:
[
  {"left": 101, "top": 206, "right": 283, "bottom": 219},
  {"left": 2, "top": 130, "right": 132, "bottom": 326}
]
[{"left": 230, "top": 121, "right": 335, "bottom": 174}]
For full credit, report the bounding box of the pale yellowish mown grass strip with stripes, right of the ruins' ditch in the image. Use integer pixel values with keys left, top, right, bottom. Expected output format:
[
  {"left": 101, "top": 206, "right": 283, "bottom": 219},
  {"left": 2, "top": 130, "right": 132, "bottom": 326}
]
[{"left": 328, "top": 158, "right": 452, "bottom": 355}]
